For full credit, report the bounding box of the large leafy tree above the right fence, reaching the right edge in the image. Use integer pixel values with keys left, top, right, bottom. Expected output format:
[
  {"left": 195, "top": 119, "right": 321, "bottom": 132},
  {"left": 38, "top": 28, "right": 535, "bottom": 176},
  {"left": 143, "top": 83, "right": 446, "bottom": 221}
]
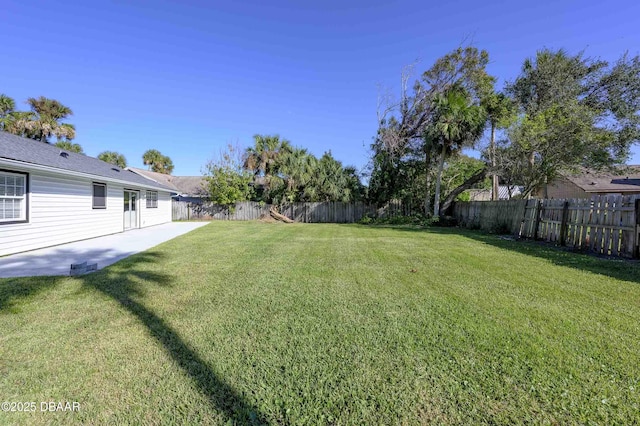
[{"left": 503, "top": 49, "right": 640, "bottom": 194}]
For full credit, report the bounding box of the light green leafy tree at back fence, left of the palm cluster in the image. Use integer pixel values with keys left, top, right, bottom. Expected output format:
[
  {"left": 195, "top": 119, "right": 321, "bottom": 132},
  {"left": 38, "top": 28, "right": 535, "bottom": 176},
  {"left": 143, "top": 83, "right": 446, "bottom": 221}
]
[{"left": 204, "top": 144, "right": 253, "bottom": 208}]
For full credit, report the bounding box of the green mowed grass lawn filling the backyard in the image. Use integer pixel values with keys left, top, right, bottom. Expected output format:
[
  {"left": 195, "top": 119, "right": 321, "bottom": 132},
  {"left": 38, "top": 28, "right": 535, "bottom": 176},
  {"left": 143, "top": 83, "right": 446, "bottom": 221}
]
[{"left": 0, "top": 222, "right": 640, "bottom": 425}]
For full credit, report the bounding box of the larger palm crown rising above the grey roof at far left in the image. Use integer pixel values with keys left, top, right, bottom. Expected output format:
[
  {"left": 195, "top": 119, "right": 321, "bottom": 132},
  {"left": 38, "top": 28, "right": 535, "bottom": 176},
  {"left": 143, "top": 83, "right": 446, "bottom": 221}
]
[{"left": 24, "top": 96, "right": 76, "bottom": 142}]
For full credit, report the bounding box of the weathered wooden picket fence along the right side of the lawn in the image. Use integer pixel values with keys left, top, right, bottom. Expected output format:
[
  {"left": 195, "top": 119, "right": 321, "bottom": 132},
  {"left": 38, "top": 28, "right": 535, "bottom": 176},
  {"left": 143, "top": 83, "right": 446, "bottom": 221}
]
[{"left": 453, "top": 195, "right": 640, "bottom": 258}]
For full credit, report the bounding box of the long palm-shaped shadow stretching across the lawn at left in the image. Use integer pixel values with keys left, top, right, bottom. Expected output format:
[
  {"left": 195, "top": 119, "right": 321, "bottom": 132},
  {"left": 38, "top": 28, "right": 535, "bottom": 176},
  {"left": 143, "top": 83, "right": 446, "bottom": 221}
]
[{"left": 0, "top": 251, "right": 267, "bottom": 424}]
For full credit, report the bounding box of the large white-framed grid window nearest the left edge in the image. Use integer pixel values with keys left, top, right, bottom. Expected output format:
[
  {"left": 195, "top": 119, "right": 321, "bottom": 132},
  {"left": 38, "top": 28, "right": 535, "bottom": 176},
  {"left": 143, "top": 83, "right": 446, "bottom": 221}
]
[{"left": 0, "top": 170, "right": 29, "bottom": 224}]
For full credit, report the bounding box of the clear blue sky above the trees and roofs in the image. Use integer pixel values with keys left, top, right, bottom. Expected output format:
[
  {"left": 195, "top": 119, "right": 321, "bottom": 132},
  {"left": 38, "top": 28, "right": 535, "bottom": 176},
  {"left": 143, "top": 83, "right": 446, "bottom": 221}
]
[{"left": 0, "top": 0, "right": 640, "bottom": 175}]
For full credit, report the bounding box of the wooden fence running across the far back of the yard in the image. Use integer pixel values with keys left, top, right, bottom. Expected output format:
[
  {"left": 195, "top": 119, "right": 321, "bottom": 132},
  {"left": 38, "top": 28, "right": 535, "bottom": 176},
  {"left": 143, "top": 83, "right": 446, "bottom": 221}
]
[{"left": 172, "top": 201, "right": 409, "bottom": 223}]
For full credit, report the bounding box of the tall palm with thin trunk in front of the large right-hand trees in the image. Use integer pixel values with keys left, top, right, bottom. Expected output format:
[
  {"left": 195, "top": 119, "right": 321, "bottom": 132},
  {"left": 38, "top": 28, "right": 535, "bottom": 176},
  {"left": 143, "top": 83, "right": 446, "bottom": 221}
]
[{"left": 428, "top": 86, "right": 485, "bottom": 217}]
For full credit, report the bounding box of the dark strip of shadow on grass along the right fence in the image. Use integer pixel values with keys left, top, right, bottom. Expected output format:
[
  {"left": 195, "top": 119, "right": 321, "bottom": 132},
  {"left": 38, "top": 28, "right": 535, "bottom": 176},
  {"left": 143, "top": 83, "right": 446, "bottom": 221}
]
[{"left": 350, "top": 225, "right": 640, "bottom": 283}]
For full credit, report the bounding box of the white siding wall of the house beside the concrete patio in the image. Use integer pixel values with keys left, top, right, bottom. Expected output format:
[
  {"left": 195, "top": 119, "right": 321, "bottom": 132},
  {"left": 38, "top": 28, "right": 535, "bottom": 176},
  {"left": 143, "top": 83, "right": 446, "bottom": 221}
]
[{"left": 0, "top": 167, "right": 171, "bottom": 256}]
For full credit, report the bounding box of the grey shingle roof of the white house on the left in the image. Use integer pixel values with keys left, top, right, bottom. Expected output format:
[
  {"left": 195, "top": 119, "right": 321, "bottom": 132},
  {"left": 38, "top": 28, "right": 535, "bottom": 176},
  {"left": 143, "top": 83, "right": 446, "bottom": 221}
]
[{"left": 0, "top": 131, "right": 172, "bottom": 191}]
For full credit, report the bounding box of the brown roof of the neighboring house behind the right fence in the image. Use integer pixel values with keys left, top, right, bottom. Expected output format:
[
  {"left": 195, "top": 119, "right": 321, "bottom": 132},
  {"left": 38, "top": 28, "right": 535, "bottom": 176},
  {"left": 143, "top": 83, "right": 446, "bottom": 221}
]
[{"left": 563, "top": 166, "right": 640, "bottom": 193}]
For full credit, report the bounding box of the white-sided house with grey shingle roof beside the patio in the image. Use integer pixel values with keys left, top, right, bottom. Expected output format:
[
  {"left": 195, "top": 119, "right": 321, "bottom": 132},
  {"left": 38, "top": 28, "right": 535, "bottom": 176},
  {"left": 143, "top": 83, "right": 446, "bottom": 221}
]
[{"left": 0, "top": 131, "right": 172, "bottom": 256}]
